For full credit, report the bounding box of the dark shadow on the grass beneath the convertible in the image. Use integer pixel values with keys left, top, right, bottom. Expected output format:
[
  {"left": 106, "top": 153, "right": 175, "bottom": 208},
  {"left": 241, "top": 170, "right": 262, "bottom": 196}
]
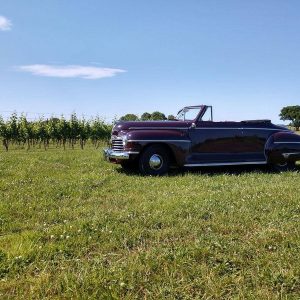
[{"left": 116, "top": 165, "right": 300, "bottom": 176}]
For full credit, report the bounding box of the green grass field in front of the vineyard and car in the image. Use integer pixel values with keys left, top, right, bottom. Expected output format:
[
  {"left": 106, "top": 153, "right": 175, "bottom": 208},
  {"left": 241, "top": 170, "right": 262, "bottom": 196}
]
[{"left": 0, "top": 149, "right": 300, "bottom": 299}]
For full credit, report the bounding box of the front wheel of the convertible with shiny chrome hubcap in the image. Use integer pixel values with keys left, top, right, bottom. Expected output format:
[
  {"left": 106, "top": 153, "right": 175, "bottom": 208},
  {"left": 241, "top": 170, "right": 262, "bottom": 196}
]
[{"left": 139, "top": 145, "right": 170, "bottom": 176}]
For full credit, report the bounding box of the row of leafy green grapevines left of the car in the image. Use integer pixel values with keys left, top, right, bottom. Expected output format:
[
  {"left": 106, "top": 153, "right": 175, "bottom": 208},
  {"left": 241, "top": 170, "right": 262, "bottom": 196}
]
[{"left": 0, "top": 113, "right": 112, "bottom": 151}]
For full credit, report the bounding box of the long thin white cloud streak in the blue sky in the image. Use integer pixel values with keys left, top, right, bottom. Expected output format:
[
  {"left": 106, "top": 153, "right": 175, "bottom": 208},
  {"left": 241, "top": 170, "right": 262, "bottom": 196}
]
[{"left": 18, "top": 65, "right": 126, "bottom": 79}]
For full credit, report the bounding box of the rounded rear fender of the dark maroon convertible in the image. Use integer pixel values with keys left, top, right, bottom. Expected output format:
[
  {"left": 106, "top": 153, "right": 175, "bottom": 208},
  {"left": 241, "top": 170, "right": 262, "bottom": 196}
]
[{"left": 265, "top": 132, "right": 300, "bottom": 163}]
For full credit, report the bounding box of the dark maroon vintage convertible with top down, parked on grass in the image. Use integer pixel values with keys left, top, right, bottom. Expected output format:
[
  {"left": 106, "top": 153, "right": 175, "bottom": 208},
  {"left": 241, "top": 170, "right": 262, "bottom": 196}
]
[{"left": 104, "top": 105, "right": 300, "bottom": 175}]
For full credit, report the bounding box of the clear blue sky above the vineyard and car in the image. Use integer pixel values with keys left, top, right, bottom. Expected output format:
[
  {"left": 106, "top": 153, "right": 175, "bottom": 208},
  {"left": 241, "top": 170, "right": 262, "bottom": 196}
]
[{"left": 0, "top": 0, "right": 300, "bottom": 123}]
